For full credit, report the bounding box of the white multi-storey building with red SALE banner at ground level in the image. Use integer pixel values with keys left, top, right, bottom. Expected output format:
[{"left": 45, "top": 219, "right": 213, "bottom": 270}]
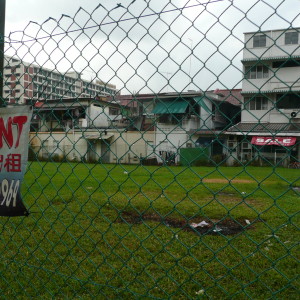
[{"left": 228, "top": 28, "right": 300, "bottom": 165}]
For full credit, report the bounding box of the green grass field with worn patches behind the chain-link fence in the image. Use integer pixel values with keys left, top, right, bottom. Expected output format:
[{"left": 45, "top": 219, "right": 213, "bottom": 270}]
[{"left": 0, "top": 162, "right": 300, "bottom": 299}]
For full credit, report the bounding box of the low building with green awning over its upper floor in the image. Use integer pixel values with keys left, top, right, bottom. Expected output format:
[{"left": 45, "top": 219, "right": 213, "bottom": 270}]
[{"left": 116, "top": 90, "right": 240, "bottom": 164}]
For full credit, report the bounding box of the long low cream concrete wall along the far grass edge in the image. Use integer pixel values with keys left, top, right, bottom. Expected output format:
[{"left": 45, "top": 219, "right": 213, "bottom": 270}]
[{"left": 30, "top": 130, "right": 155, "bottom": 164}]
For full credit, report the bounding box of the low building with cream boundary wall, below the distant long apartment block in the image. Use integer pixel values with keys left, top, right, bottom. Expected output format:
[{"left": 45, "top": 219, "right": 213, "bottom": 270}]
[{"left": 29, "top": 98, "right": 154, "bottom": 164}]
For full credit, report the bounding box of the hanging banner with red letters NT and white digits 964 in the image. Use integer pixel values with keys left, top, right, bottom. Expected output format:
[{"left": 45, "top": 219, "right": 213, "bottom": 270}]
[{"left": 0, "top": 106, "right": 32, "bottom": 216}]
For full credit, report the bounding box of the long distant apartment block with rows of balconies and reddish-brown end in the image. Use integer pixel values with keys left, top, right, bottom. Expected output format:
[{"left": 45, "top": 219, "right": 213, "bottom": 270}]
[{"left": 3, "top": 56, "right": 116, "bottom": 104}]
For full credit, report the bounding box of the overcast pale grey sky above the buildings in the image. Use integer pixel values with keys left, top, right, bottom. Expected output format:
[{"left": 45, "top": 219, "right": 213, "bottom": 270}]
[{"left": 2, "top": 0, "right": 300, "bottom": 94}]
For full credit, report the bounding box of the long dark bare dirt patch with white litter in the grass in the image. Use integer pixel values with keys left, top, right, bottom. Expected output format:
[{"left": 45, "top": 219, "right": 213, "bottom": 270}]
[{"left": 116, "top": 211, "right": 253, "bottom": 235}]
